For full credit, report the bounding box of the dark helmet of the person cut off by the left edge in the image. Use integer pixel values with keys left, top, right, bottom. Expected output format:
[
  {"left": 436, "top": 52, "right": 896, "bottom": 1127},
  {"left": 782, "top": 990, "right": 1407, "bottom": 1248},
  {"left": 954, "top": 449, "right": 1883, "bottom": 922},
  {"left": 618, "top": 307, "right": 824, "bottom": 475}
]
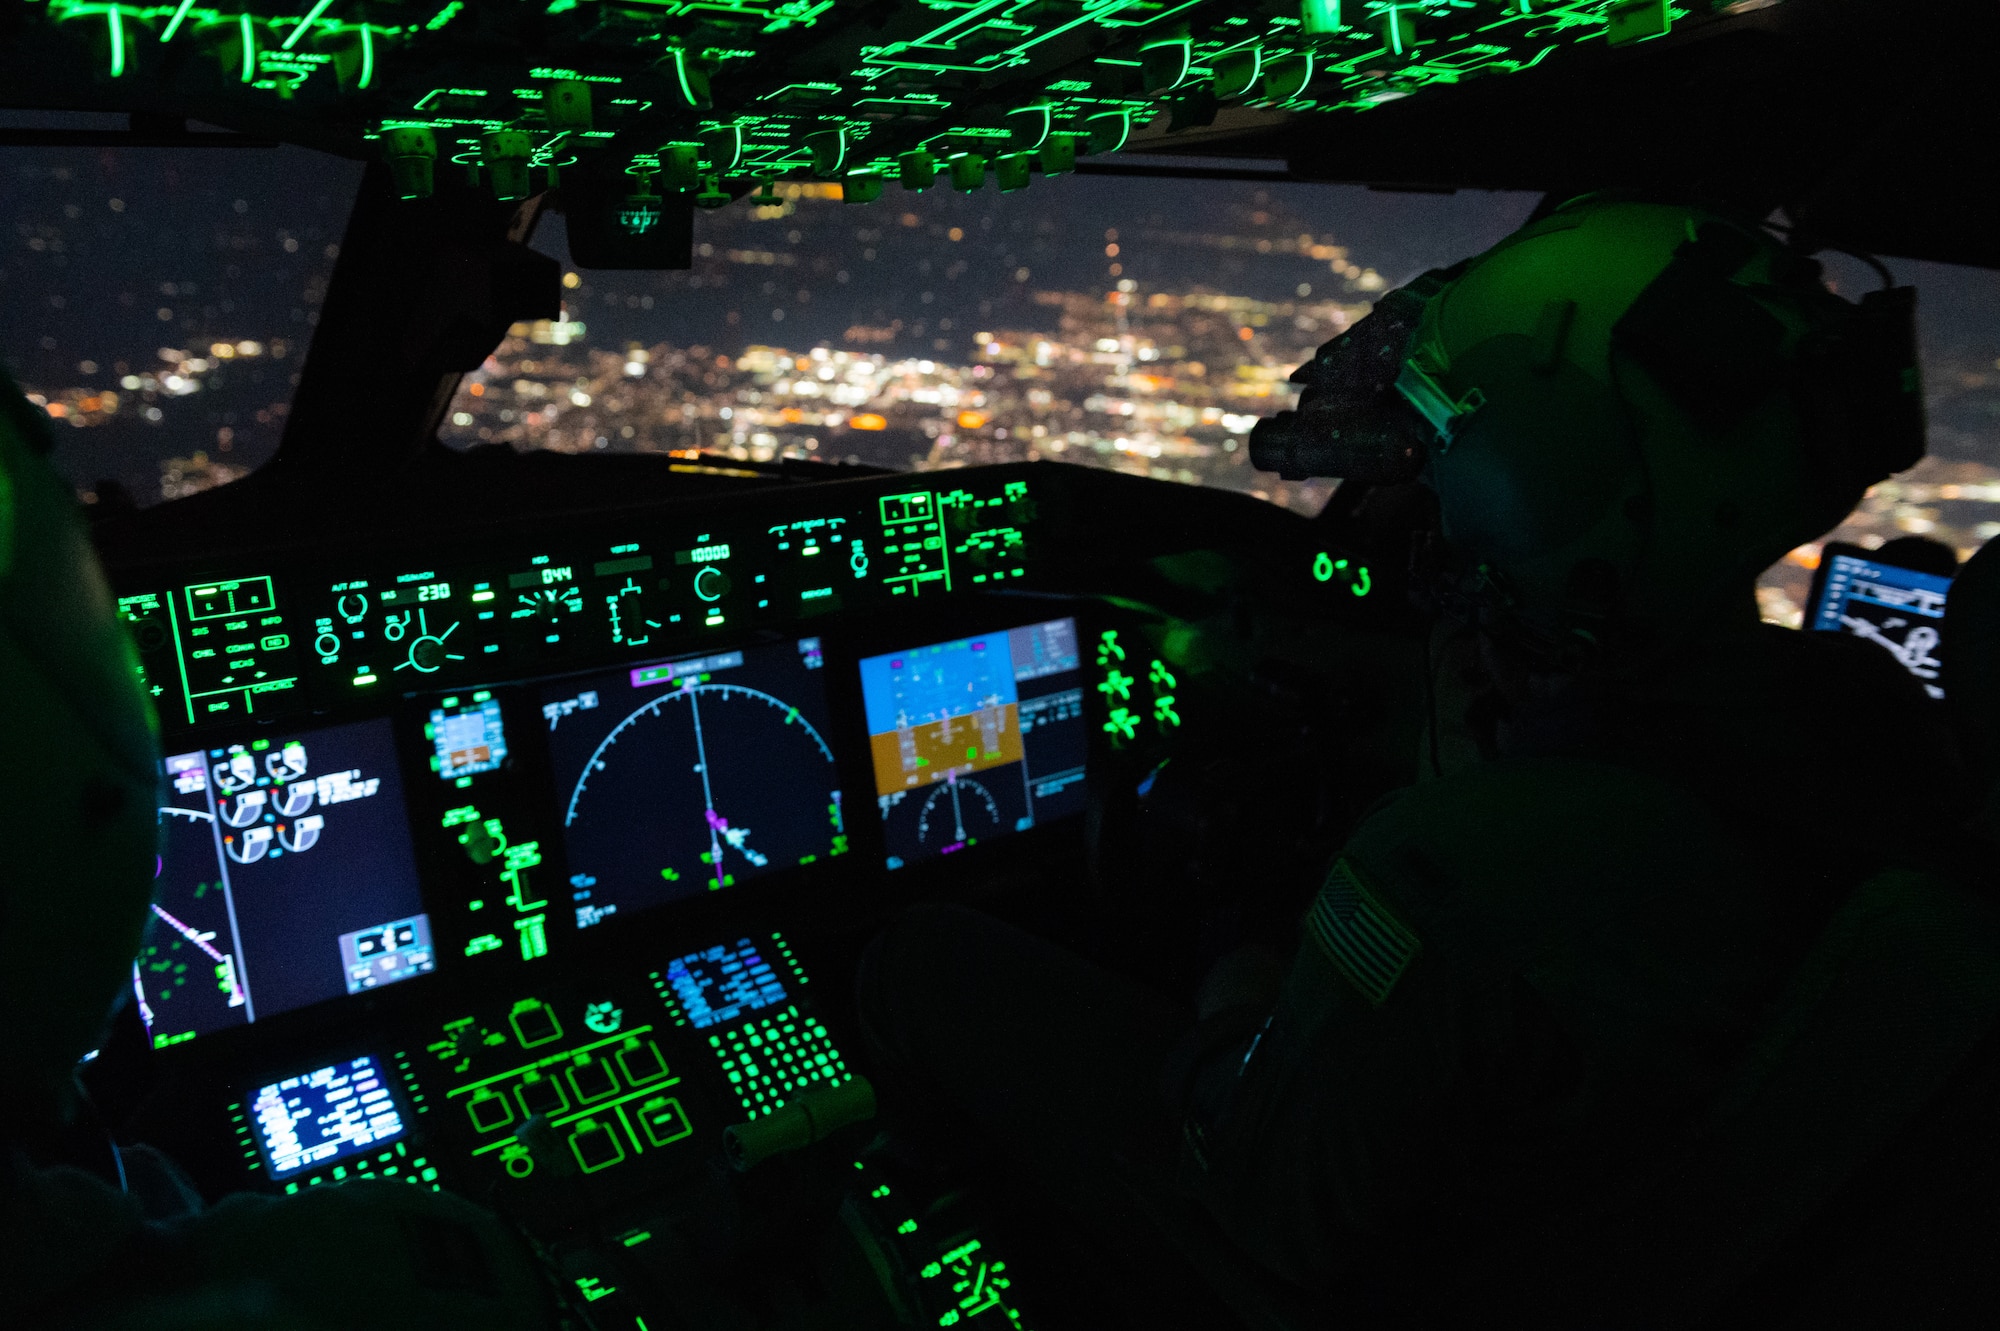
[{"left": 0, "top": 365, "right": 158, "bottom": 1137}]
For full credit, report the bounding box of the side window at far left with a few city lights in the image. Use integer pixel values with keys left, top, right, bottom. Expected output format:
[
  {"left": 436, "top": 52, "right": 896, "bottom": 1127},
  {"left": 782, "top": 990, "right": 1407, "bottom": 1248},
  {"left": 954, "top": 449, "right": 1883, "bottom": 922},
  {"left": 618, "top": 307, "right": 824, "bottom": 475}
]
[{"left": 0, "top": 112, "right": 362, "bottom": 508}]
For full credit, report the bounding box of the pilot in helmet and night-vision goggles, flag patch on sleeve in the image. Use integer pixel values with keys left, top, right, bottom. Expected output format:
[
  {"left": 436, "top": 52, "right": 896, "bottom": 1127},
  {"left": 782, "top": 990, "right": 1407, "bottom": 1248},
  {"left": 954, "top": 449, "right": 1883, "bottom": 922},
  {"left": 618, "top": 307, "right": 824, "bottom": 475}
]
[{"left": 860, "top": 198, "right": 1968, "bottom": 1325}]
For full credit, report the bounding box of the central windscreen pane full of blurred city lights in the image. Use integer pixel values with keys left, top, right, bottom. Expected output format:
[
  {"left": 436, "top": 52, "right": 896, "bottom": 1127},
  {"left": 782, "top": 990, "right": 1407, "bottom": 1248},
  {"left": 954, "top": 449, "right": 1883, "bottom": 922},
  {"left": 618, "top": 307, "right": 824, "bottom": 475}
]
[{"left": 444, "top": 170, "right": 1534, "bottom": 512}]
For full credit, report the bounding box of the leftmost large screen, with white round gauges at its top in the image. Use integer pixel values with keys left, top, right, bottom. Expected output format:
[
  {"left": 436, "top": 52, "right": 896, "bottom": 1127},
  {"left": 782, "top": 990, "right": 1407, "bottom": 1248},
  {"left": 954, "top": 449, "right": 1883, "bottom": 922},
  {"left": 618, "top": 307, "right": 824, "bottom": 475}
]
[{"left": 132, "top": 719, "right": 436, "bottom": 1047}]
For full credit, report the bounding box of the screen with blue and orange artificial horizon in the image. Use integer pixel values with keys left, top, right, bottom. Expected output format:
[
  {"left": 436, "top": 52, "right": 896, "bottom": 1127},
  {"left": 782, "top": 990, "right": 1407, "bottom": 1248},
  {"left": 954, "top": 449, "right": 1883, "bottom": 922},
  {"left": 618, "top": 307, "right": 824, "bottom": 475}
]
[{"left": 860, "top": 620, "right": 1086, "bottom": 869}]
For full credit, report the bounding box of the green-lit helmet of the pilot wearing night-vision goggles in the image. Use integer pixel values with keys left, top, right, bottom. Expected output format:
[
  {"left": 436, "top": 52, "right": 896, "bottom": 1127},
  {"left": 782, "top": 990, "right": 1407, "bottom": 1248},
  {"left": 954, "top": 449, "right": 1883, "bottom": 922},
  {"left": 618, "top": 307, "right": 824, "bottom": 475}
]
[{"left": 1396, "top": 198, "right": 1924, "bottom": 638}]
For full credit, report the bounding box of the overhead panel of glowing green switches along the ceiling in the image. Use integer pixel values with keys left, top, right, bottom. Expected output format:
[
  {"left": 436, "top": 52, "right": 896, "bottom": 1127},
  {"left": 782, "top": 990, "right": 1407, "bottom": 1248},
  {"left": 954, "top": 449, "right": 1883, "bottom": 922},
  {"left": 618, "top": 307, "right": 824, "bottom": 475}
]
[{"left": 23, "top": 0, "right": 1770, "bottom": 201}]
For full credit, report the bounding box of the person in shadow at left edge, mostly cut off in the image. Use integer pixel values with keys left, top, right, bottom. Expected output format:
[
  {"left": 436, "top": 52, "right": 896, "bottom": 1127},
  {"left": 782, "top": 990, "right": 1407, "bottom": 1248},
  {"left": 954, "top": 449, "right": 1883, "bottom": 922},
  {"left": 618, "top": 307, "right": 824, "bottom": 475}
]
[{"left": 0, "top": 365, "right": 552, "bottom": 1331}]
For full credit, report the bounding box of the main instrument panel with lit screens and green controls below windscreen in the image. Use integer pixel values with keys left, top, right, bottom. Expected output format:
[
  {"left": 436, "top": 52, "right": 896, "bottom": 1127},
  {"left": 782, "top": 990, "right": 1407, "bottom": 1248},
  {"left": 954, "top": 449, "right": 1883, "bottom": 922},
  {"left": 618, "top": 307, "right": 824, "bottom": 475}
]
[{"left": 86, "top": 453, "right": 1364, "bottom": 1325}]
